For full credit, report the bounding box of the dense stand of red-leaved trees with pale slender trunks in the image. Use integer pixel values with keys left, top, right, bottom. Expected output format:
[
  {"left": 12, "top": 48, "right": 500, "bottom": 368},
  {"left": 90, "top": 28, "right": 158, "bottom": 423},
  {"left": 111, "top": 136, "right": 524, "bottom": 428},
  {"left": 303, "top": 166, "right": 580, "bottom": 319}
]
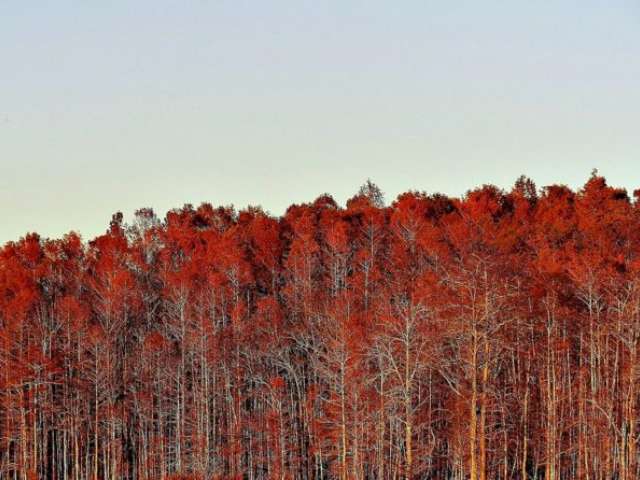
[{"left": 0, "top": 174, "right": 640, "bottom": 480}]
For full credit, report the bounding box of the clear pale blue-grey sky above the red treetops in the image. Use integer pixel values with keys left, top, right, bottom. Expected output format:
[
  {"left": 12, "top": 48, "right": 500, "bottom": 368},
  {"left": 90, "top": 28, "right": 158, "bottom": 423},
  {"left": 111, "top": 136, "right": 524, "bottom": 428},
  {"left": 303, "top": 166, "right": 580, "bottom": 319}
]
[{"left": 0, "top": 0, "right": 640, "bottom": 244}]
